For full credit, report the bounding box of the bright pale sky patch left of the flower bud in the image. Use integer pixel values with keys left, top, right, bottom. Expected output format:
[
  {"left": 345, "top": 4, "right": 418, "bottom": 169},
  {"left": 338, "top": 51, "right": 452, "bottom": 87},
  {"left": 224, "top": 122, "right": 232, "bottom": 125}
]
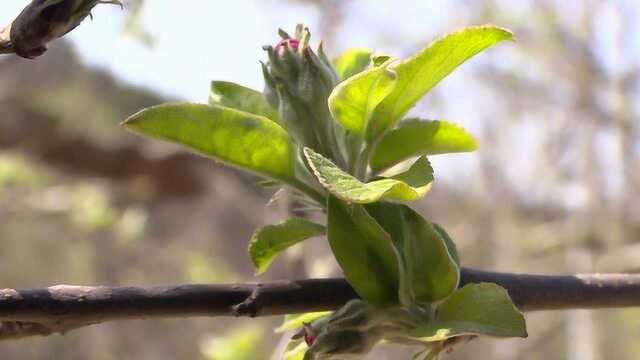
[{"left": 0, "top": 0, "right": 313, "bottom": 101}]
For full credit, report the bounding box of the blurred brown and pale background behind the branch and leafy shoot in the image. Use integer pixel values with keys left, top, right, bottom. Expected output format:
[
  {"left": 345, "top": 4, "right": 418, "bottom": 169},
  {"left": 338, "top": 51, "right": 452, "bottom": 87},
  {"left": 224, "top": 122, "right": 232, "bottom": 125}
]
[{"left": 0, "top": 0, "right": 640, "bottom": 360}]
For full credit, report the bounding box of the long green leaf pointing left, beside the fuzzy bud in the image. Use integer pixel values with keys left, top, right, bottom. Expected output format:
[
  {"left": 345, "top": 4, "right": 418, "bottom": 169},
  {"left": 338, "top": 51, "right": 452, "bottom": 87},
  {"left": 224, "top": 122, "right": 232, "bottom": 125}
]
[{"left": 123, "top": 103, "right": 296, "bottom": 182}]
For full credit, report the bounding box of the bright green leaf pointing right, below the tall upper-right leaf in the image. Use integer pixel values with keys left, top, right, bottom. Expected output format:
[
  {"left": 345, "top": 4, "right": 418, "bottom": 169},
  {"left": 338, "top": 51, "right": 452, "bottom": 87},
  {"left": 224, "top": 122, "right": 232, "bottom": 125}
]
[{"left": 371, "top": 119, "right": 478, "bottom": 172}]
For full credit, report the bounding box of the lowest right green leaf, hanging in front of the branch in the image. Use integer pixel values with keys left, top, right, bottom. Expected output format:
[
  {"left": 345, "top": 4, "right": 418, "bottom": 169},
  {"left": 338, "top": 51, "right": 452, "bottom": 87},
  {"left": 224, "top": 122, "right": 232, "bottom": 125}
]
[{"left": 411, "top": 283, "right": 527, "bottom": 341}]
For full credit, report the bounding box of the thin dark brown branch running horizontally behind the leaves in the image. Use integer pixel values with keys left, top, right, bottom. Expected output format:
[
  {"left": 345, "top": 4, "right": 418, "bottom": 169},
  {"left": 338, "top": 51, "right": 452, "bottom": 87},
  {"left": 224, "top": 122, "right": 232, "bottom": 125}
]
[{"left": 0, "top": 269, "right": 640, "bottom": 339}]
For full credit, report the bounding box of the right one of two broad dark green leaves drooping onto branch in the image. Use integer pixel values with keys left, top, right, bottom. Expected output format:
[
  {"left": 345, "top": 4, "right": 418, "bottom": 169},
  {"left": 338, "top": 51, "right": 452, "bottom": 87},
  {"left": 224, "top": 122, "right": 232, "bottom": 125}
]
[{"left": 366, "top": 203, "right": 460, "bottom": 303}]
